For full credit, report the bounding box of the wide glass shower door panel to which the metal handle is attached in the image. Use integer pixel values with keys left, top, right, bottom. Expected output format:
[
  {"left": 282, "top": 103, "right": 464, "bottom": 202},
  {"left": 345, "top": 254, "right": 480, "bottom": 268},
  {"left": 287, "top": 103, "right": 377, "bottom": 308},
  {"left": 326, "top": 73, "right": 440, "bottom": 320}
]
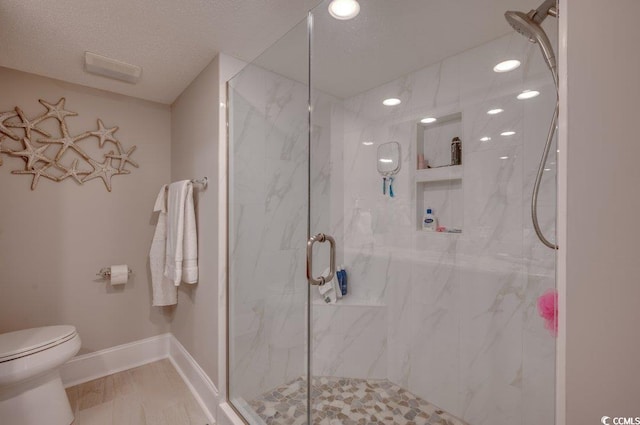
[{"left": 308, "top": 0, "right": 557, "bottom": 425}]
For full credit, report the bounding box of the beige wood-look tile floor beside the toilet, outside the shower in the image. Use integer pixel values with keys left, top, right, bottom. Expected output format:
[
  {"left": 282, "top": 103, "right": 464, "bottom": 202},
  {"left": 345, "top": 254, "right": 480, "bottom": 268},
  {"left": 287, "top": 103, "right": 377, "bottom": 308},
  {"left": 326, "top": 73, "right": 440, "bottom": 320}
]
[{"left": 67, "top": 359, "right": 209, "bottom": 425}]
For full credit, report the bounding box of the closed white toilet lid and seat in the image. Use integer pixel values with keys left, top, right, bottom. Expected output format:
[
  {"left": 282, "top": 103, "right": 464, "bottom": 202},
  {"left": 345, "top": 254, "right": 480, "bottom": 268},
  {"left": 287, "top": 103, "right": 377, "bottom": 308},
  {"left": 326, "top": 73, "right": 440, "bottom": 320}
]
[{"left": 0, "top": 325, "right": 76, "bottom": 363}]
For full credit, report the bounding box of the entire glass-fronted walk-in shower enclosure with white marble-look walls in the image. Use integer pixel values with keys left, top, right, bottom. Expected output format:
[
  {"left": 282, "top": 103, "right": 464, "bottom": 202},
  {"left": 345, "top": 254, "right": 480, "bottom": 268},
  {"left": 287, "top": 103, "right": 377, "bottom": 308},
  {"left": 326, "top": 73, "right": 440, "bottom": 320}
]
[{"left": 227, "top": 0, "right": 557, "bottom": 425}]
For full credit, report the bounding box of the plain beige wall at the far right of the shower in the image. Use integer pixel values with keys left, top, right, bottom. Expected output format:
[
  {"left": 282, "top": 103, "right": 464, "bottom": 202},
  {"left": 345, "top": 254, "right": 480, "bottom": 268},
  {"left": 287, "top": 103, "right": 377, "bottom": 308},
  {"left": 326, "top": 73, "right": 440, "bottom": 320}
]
[{"left": 559, "top": 0, "right": 640, "bottom": 418}]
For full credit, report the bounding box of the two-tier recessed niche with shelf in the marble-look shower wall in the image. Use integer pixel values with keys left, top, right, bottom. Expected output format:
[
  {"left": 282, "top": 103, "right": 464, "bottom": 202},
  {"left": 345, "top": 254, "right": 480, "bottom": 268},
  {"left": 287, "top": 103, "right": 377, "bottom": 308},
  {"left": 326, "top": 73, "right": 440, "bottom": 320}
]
[{"left": 415, "top": 112, "right": 464, "bottom": 234}]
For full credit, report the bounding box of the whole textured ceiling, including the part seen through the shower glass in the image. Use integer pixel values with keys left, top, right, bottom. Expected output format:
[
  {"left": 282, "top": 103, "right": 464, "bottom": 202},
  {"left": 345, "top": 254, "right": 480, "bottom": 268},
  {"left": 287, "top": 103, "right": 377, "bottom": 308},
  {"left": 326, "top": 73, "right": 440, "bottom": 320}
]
[{"left": 0, "top": 0, "right": 538, "bottom": 104}]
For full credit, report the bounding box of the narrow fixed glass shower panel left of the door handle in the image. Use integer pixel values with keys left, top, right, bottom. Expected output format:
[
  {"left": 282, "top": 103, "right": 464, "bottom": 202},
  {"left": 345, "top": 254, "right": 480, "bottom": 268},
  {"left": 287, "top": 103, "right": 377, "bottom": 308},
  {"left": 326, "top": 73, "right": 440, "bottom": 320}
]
[{"left": 227, "top": 15, "right": 309, "bottom": 423}]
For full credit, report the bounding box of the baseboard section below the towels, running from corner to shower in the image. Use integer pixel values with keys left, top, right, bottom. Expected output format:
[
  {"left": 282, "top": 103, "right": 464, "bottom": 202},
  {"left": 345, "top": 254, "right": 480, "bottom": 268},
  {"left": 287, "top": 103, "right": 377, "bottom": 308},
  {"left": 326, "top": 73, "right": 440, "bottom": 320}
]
[{"left": 169, "top": 335, "right": 220, "bottom": 423}]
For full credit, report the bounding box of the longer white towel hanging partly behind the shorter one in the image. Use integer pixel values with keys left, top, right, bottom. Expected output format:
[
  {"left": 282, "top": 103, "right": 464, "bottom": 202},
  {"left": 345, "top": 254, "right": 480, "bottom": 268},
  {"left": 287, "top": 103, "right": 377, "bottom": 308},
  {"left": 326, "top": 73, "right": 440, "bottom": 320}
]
[{"left": 149, "top": 185, "right": 178, "bottom": 306}]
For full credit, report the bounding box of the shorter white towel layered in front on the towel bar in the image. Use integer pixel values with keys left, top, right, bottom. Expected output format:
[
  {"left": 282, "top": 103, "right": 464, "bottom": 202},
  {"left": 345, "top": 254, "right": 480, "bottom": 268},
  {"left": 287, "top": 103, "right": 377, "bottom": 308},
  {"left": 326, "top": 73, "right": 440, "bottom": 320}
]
[{"left": 164, "top": 180, "right": 198, "bottom": 286}]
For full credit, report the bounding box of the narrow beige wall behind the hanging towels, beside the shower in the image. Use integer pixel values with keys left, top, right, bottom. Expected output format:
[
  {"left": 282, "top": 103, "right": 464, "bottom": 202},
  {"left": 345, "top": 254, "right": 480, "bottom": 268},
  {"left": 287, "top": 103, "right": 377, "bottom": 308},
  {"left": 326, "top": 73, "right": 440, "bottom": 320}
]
[{"left": 171, "top": 54, "right": 219, "bottom": 383}]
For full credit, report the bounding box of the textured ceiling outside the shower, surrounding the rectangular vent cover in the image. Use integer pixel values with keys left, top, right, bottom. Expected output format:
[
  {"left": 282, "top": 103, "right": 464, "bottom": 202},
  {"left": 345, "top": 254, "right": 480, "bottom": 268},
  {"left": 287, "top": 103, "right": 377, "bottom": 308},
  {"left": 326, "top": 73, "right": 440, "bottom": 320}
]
[{"left": 0, "top": 0, "right": 318, "bottom": 104}]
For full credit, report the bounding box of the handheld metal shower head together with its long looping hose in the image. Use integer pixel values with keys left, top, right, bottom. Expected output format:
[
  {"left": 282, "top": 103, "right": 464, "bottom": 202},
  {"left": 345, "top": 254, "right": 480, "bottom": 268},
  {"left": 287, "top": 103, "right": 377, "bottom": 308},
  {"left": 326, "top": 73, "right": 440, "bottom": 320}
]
[{"left": 504, "top": 0, "right": 559, "bottom": 249}]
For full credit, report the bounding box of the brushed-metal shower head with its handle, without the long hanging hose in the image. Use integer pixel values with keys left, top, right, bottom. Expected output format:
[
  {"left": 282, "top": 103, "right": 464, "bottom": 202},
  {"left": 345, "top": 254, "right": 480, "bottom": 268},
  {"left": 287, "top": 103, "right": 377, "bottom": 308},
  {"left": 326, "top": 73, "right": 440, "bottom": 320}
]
[{"left": 504, "top": 0, "right": 558, "bottom": 84}]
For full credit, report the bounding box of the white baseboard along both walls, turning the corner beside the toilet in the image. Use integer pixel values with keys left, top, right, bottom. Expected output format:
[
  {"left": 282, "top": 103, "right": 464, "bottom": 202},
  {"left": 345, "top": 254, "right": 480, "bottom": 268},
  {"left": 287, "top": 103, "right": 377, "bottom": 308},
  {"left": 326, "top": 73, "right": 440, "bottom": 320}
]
[{"left": 60, "top": 333, "right": 220, "bottom": 424}]
